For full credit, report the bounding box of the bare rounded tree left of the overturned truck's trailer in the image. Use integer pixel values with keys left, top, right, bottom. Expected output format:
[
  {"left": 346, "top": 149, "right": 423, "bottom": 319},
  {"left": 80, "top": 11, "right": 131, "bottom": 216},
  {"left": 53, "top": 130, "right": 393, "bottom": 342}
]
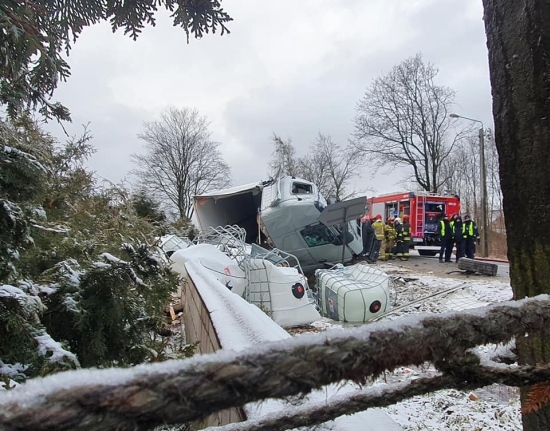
[{"left": 132, "top": 107, "right": 230, "bottom": 220}]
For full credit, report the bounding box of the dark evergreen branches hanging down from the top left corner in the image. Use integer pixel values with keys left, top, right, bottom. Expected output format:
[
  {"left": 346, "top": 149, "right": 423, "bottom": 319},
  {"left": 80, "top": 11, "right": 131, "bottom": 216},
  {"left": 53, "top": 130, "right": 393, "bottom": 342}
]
[{"left": 0, "top": 0, "right": 232, "bottom": 120}]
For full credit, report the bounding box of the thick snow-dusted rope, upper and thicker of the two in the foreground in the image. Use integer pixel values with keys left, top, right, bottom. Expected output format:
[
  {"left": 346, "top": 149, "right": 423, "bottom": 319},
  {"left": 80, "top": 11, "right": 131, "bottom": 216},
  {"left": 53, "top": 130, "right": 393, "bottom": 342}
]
[{"left": 0, "top": 296, "right": 550, "bottom": 431}]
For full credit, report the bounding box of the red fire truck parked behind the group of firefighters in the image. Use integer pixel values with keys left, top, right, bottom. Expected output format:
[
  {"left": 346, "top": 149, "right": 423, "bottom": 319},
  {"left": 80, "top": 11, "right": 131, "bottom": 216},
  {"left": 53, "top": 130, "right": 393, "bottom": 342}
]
[{"left": 367, "top": 192, "right": 460, "bottom": 256}]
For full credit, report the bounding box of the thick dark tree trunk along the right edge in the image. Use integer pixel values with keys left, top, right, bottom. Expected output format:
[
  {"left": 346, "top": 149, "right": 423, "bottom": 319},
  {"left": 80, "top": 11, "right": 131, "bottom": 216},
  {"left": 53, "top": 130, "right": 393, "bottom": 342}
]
[{"left": 483, "top": 0, "right": 550, "bottom": 430}]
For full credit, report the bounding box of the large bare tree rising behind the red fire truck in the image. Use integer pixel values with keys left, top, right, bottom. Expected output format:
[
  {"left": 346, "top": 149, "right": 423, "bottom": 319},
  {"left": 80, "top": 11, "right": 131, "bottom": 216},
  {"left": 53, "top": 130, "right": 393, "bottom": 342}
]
[{"left": 354, "top": 54, "right": 463, "bottom": 192}]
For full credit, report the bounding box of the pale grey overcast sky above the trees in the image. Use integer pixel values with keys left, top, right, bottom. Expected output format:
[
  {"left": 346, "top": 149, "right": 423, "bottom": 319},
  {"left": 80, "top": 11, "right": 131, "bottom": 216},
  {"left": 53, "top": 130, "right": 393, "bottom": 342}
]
[{"left": 48, "top": 0, "right": 492, "bottom": 197}]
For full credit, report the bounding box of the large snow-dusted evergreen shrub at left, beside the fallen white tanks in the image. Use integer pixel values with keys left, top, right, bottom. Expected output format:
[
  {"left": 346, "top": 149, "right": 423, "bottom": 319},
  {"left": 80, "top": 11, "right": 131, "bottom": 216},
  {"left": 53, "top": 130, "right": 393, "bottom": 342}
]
[{"left": 0, "top": 115, "right": 193, "bottom": 388}]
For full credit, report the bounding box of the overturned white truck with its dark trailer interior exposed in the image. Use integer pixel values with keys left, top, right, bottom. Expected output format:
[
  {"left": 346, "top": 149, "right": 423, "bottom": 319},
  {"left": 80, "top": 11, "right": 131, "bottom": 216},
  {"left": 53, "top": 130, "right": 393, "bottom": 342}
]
[{"left": 194, "top": 176, "right": 363, "bottom": 274}]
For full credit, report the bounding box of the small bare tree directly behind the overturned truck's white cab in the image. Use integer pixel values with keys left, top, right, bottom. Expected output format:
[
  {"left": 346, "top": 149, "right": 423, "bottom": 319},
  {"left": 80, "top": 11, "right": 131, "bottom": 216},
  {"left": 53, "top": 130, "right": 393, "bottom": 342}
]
[{"left": 298, "top": 133, "right": 363, "bottom": 200}]
